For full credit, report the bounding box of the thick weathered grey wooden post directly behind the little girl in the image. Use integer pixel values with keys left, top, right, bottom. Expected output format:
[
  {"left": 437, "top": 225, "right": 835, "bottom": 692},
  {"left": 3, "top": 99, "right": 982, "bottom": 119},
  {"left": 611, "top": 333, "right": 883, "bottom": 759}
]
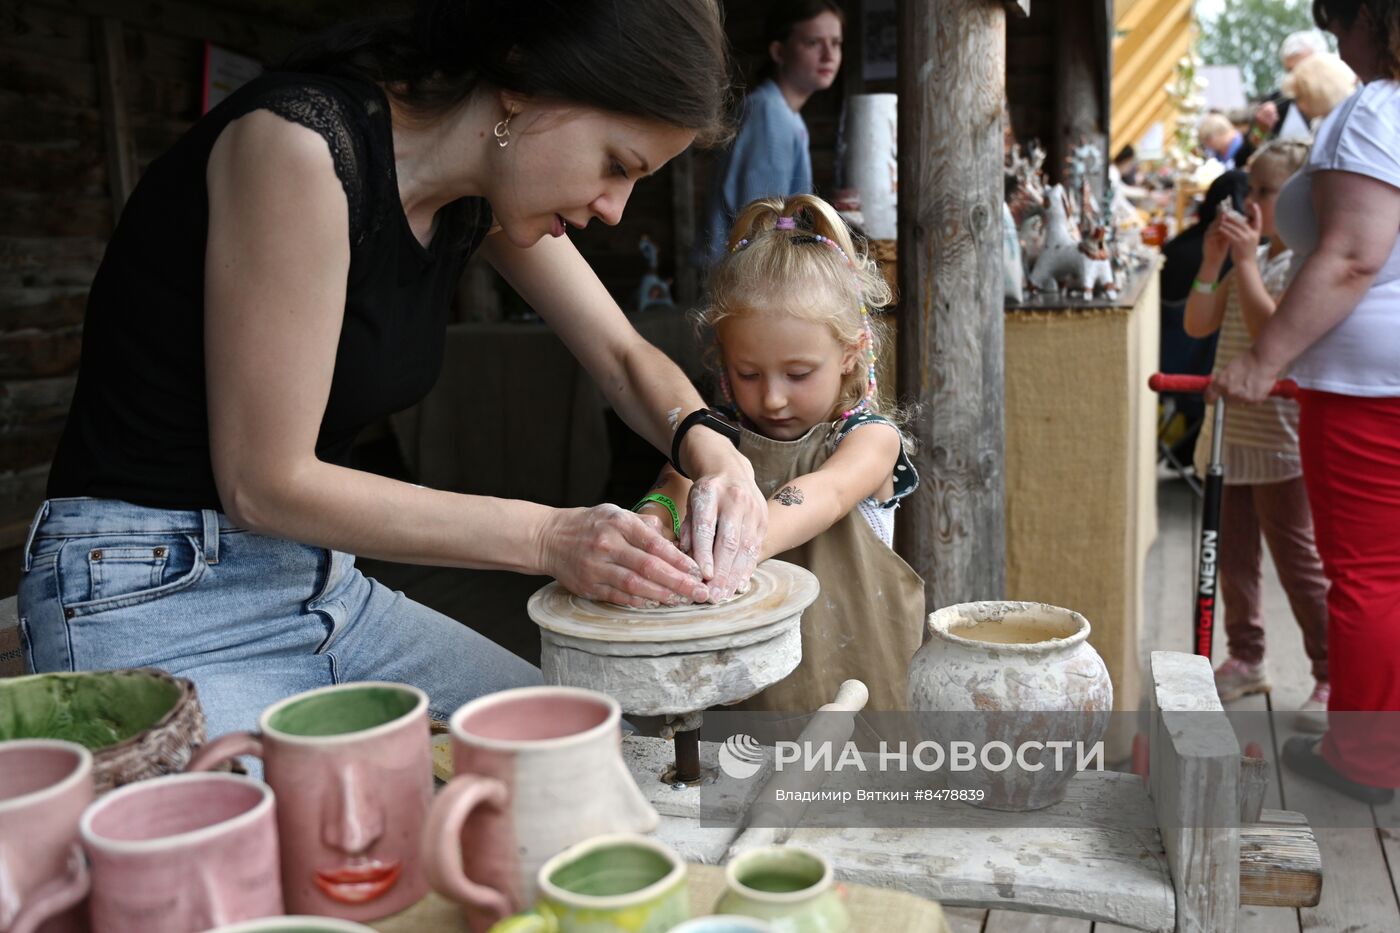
[{"left": 897, "top": 0, "right": 1007, "bottom": 609}]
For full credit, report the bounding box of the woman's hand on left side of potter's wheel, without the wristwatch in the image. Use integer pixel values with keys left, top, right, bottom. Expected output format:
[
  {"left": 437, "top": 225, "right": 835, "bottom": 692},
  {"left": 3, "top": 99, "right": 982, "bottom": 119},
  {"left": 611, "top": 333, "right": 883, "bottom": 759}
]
[{"left": 540, "top": 504, "right": 710, "bottom": 608}]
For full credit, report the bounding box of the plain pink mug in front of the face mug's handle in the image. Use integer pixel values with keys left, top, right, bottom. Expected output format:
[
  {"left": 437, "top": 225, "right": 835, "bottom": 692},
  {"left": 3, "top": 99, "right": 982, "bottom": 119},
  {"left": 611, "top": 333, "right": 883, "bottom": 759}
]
[{"left": 80, "top": 773, "right": 281, "bottom": 933}]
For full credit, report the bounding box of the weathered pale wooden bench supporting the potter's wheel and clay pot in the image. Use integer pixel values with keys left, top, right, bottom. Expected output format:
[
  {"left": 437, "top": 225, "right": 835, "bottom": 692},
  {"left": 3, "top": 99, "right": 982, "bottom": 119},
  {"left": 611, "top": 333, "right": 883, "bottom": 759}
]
[{"left": 623, "top": 651, "right": 1322, "bottom": 933}]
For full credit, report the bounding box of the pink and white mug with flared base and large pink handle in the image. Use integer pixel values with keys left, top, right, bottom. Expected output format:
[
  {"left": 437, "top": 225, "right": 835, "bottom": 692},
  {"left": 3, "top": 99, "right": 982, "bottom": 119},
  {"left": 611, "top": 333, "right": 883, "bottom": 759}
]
[{"left": 423, "top": 686, "right": 661, "bottom": 930}]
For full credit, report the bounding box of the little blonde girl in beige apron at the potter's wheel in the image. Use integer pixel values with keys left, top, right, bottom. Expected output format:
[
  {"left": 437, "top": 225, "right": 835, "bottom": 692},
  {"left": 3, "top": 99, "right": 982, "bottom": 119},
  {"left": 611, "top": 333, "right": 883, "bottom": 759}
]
[{"left": 638, "top": 195, "right": 924, "bottom": 712}]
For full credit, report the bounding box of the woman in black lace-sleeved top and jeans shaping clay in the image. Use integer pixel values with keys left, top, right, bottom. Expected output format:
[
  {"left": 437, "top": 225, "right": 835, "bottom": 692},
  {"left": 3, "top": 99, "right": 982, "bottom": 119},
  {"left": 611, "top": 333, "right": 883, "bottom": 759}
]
[{"left": 20, "top": 0, "right": 766, "bottom": 733}]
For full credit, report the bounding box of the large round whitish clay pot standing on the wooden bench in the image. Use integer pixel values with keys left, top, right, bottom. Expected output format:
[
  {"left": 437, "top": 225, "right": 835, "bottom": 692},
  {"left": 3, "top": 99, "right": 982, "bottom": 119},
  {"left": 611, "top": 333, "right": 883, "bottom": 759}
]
[{"left": 909, "top": 602, "right": 1113, "bottom": 810}]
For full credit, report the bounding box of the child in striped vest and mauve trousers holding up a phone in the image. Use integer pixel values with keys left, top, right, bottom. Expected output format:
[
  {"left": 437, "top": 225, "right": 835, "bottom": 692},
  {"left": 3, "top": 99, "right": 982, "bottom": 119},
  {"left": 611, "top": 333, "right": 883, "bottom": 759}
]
[{"left": 1186, "top": 140, "right": 1329, "bottom": 731}]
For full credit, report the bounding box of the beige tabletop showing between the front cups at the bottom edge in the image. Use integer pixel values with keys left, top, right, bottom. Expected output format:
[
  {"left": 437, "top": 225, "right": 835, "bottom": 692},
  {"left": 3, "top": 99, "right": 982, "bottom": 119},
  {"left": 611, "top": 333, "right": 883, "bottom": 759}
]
[{"left": 370, "top": 864, "right": 949, "bottom": 933}]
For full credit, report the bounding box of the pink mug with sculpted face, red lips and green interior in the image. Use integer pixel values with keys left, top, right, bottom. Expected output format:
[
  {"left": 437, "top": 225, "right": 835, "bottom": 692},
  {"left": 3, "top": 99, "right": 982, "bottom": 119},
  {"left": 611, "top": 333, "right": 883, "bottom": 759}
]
[{"left": 189, "top": 682, "right": 433, "bottom": 922}]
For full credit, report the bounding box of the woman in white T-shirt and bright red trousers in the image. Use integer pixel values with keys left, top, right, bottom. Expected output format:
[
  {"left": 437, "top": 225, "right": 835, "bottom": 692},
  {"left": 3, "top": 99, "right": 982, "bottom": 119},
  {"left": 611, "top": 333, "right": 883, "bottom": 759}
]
[{"left": 1212, "top": 0, "right": 1400, "bottom": 803}]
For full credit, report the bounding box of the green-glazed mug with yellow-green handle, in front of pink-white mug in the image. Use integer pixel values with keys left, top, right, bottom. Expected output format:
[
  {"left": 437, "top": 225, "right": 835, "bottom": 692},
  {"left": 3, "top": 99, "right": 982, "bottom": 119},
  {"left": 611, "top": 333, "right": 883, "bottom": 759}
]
[{"left": 491, "top": 835, "right": 690, "bottom": 933}]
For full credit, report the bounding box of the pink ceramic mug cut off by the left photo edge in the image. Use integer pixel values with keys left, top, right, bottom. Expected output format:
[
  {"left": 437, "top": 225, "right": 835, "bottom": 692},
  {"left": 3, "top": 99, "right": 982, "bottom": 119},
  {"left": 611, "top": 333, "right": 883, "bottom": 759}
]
[{"left": 0, "top": 738, "right": 92, "bottom": 933}]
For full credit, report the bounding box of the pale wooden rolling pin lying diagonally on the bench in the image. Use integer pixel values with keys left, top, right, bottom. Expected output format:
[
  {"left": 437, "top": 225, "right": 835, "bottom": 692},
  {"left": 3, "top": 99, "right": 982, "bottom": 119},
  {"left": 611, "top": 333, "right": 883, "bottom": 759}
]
[{"left": 725, "top": 679, "right": 871, "bottom": 862}]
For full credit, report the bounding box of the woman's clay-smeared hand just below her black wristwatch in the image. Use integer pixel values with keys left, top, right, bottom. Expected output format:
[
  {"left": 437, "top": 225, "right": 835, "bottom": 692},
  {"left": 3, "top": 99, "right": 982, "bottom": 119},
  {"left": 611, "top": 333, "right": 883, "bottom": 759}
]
[{"left": 680, "top": 430, "right": 769, "bottom": 602}]
